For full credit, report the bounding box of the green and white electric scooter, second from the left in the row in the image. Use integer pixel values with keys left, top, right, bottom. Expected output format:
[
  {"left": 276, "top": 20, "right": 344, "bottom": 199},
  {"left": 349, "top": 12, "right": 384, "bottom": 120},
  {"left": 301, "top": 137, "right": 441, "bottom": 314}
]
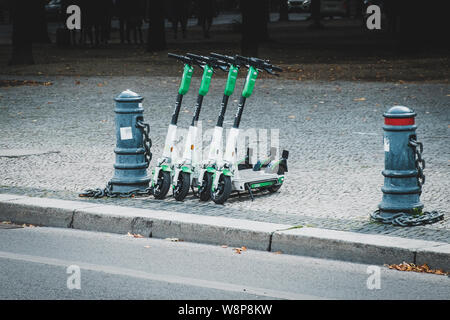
[{"left": 172, "top": 53, "right": 228, "bottom": 201}]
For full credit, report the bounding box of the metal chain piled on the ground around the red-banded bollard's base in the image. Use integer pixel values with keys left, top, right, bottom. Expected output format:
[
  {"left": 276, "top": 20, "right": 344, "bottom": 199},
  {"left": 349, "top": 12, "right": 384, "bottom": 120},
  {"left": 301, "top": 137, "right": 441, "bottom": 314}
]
[{"left": 370, "top": 209, "right": 444, "bottom": 227}]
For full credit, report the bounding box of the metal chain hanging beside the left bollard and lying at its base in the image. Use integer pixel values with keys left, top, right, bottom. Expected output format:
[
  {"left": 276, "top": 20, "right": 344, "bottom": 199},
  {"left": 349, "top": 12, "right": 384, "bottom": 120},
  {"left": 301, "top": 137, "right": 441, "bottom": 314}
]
[{"left": 78, "top": 120, "right": 153, "bottom": 198}]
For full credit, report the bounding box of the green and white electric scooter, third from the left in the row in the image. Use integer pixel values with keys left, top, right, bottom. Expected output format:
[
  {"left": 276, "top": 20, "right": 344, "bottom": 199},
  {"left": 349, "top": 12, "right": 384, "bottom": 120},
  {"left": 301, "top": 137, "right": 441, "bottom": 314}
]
[{"left": 194, "top": 53, "right": 240, "bottom": 201}]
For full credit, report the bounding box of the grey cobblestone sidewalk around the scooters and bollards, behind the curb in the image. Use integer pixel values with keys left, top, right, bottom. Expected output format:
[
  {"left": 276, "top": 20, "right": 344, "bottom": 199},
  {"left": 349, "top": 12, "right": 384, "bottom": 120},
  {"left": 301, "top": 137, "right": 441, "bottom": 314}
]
[{"left": 0, "top": 76, "right": 450, "bottom": 243}]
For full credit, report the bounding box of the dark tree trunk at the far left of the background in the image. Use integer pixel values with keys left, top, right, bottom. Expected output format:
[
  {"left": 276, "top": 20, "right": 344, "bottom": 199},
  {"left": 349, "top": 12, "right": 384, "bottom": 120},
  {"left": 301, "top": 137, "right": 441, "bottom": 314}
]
[{"left": 9, "top": 0, "right": 34, "bottom": 65}]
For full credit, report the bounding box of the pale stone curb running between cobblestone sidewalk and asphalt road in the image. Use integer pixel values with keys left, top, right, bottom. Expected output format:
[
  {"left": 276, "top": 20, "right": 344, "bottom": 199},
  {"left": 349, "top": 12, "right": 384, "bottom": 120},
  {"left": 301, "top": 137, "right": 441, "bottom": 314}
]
[{"left": 0, "top": 194, "right": 450, "bottom": 271}]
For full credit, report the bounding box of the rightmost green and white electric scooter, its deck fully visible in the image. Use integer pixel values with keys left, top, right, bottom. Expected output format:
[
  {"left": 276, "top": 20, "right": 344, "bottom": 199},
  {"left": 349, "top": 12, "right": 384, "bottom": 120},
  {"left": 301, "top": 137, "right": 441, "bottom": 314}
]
[{"left": 211, "top": 55, "right": 289, "bottom": 204}]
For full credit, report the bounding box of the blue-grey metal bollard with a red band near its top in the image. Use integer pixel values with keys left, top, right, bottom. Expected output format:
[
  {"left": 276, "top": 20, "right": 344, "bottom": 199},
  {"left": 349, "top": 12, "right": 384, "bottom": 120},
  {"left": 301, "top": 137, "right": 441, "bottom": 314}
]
[{"left": 378, "top": 106, "right": 425, "bottom": 216}]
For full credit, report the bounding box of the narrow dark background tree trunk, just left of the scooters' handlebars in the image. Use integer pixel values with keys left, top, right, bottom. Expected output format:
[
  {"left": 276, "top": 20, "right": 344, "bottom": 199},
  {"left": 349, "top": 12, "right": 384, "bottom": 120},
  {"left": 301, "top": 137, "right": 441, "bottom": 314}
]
[{"left": 147, "top": 0, "right": 167, "bottom": 52}]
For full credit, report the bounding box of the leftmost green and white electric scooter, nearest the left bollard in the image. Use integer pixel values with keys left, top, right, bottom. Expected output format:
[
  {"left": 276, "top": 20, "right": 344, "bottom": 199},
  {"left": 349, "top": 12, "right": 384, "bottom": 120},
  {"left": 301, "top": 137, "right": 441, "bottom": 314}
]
[{"left": 151, "top": 53, "right": 198, "bottom": 199}]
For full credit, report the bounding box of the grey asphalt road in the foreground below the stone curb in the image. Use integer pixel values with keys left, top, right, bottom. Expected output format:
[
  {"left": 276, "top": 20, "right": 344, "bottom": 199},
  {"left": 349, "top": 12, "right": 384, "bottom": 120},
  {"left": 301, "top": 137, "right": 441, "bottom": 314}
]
[{"left": 0, "top": 228, "right": 450, "bottom": 300}]
